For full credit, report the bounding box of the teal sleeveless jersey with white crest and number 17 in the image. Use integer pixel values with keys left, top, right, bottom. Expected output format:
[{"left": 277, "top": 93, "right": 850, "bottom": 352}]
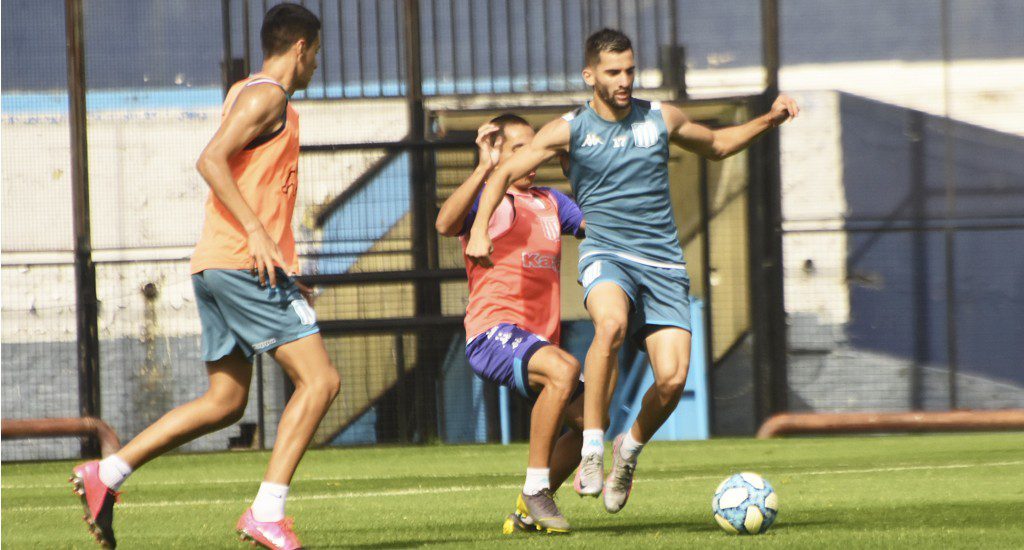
[{"left": 562, "top": 99, "right": 685, "bottom": 268}]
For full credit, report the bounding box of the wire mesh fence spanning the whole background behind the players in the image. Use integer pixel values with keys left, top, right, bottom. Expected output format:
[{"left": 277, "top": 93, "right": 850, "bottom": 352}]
[{"left": 2, "top": 0, "right": 1024, "bottom": 460}]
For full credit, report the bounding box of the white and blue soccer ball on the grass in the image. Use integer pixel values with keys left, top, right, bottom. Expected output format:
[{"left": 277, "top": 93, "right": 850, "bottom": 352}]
[{"left": 712, "top": 472, "right": 778, "bottom": 535}]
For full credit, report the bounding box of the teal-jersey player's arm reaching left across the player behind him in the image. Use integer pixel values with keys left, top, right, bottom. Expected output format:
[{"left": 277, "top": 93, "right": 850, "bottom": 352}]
[{"left": 466, "top": 118, "right": 569, "bottom": 267}]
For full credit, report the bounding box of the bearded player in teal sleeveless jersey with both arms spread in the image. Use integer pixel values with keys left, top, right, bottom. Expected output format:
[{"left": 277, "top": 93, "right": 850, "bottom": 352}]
[{"left": 466, "top": 29, "right": 800, "bottom": 513}]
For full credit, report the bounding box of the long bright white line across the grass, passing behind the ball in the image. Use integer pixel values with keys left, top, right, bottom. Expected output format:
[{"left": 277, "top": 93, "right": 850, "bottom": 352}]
[{"left": 3, "top": 460, "right": 1024, "bottom": 512}]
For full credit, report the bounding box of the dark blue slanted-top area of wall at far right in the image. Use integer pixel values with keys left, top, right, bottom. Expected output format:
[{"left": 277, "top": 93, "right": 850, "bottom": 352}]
[{"left": 840, "top": 95, "right": 1024, "bottom": 385}]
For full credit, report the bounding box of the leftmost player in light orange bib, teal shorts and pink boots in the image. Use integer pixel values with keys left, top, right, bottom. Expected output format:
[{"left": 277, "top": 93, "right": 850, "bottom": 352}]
[{"left": 72, "top": 3, "right": 340, "bottom": 549}]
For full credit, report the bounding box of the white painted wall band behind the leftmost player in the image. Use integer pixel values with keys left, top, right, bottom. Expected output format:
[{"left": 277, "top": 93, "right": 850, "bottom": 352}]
[{"left": 0, "top": 96, "right": 408, "bottom": 343}]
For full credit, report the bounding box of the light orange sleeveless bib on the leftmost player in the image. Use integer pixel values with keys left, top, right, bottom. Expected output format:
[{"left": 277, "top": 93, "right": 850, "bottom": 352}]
[{"left": 190, "top": 75, "right": 299, "bottom": 273}]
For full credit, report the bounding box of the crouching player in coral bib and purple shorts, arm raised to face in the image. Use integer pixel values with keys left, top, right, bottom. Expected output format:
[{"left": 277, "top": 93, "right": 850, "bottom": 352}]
[{"left": 436, "top": 115, "right": 585, "bottom": 535}]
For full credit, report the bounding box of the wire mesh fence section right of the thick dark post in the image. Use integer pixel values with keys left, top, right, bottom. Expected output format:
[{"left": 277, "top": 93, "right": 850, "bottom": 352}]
[{"left": 781, "top": 0, "right": 1024, "bottom": 412}]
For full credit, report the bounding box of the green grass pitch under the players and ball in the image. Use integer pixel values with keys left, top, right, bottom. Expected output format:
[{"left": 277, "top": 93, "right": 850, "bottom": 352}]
[{"left": 2, "top": 433, "right": 1024, "bottom": 549}]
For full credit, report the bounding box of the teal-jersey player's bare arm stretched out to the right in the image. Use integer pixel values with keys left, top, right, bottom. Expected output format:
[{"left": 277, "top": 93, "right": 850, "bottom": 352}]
[{"left": 662, "top": 95, "right": 800, "bottom": 161}]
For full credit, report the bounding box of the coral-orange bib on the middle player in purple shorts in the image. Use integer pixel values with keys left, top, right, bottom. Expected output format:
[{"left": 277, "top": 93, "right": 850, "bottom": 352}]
[{"left": 462, "top": 188, "right": 562, "bottom": 345}]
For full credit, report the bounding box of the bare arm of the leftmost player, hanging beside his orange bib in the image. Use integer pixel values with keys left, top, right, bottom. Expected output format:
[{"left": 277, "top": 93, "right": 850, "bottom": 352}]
[{"left": 196, "top": 84, "right": 288, "bottom": 287}]
